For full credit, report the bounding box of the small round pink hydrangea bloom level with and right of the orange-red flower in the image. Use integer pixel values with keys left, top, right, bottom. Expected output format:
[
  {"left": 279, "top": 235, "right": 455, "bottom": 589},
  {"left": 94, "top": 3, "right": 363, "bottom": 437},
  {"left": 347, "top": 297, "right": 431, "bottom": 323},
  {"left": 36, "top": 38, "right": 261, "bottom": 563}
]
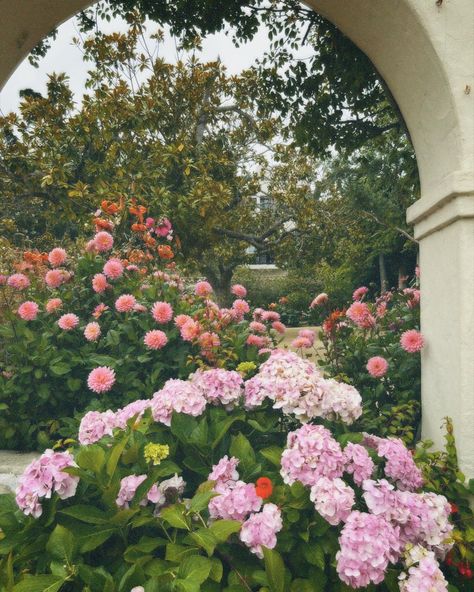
[{"left": 310, "top": 477, "right": 355, "bottom": 526}]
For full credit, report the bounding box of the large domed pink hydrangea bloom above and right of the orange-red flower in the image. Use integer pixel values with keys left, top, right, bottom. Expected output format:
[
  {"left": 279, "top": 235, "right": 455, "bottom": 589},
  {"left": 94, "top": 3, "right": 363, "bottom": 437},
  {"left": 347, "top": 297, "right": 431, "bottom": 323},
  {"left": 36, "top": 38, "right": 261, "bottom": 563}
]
[{"left": 281, "top": 424, "right": 344, "bottom": 486}]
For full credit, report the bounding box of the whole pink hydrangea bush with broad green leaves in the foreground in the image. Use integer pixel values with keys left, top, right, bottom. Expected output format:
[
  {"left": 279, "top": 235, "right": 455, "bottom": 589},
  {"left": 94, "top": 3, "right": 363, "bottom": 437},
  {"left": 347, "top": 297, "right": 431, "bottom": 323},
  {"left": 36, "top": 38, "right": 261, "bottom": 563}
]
[{"left": 0, "top": 349, "right": 467, "bottom": 592}]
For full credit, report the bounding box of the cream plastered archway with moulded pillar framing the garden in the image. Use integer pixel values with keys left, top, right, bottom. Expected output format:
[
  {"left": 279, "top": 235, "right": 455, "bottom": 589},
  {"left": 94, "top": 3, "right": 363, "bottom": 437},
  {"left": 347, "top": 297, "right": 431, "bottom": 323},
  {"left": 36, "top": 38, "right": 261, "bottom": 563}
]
[{"left": 0, "top": 0, "right": 474, "bottom": 476}]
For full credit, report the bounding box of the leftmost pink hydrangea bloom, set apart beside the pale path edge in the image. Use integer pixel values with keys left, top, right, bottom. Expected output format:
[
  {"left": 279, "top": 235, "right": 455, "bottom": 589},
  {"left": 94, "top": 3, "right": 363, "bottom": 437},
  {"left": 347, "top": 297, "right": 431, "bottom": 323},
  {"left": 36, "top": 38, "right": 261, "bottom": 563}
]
[{"left": 16, "top": 450, "right": 79, "bottom": 518}]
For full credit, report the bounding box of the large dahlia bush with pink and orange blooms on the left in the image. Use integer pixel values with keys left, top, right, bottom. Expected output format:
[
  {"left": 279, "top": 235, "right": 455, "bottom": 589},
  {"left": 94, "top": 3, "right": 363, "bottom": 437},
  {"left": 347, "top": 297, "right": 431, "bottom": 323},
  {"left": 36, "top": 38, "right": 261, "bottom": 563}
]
[{"left": 0, "top": 202, "right": 285, "bottom": 450}]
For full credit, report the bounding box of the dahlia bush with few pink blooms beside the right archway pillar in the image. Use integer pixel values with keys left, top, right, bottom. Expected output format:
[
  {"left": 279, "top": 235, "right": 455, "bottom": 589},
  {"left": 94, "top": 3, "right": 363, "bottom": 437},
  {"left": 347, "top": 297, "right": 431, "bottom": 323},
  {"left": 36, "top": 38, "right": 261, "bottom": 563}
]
[{"left": 308, "top": 277, "right": 425, "bottom": 443}]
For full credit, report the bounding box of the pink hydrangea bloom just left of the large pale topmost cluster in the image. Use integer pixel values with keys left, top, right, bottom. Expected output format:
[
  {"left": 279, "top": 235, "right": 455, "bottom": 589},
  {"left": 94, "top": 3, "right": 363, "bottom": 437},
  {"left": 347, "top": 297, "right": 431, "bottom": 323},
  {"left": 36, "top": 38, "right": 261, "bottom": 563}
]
[{"left": 192, "top": 368, "right": 243, "bottom": 405}]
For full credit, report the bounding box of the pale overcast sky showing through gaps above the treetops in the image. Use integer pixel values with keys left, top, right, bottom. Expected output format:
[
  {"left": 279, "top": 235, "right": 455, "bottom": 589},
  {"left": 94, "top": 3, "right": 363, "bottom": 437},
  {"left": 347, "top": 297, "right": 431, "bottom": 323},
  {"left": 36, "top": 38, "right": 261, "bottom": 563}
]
[{"left": 0, "top": 13, "right": 276, "bottom": 114}]
